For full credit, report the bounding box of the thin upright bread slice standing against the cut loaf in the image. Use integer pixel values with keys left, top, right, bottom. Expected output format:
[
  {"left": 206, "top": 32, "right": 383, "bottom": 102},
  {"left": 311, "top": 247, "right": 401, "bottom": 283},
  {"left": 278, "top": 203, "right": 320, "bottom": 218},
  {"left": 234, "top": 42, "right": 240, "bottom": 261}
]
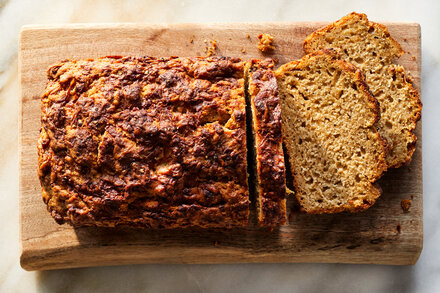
[{"left": 247, "top": 59, "right": 286, "bottom": 226}]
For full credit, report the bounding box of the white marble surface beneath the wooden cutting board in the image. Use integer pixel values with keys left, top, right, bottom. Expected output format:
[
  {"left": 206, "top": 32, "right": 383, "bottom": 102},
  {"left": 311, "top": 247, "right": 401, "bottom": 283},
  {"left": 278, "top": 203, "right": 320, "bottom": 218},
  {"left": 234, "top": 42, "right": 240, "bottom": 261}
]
[{"left": 0, "top": 0, "right": 440, "bottom": 292}]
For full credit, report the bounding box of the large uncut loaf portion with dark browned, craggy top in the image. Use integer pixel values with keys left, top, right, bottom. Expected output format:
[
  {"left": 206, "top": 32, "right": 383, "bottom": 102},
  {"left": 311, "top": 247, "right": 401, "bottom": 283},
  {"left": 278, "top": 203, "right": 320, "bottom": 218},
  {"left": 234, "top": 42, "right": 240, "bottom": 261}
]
[{"left": 38, "top": 57, "right": 249, "bottom": 228}]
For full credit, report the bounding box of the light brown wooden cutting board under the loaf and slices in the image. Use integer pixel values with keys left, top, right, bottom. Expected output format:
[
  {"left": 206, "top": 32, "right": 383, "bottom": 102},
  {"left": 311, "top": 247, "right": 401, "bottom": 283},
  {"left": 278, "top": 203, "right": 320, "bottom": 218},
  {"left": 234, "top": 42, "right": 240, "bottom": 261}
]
[{"left": 19, "top": 23, "right": 423, "bottom": 270}]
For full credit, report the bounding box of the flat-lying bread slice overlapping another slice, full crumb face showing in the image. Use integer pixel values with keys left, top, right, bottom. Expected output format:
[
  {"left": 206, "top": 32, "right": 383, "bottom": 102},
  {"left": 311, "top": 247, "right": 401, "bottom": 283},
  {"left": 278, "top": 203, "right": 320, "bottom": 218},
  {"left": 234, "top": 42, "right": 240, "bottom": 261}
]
[{"left": 276, "top": 50, "right": 386, "bottom": 213}]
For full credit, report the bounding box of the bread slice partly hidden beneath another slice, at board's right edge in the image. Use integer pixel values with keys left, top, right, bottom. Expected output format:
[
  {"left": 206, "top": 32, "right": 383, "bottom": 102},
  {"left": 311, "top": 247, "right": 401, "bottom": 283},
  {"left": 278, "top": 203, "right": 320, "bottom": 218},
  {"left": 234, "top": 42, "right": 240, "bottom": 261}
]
[{"left": 304, "top": 12, "right": 422, "bottom": 167}]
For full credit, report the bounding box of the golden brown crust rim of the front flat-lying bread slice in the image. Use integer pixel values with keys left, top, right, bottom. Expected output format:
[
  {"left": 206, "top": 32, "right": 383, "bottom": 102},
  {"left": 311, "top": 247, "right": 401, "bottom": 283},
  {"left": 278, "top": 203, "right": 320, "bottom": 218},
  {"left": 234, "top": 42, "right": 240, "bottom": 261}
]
[{"left": 275, "top": 49, "right": 387, "bottom": 214}]
